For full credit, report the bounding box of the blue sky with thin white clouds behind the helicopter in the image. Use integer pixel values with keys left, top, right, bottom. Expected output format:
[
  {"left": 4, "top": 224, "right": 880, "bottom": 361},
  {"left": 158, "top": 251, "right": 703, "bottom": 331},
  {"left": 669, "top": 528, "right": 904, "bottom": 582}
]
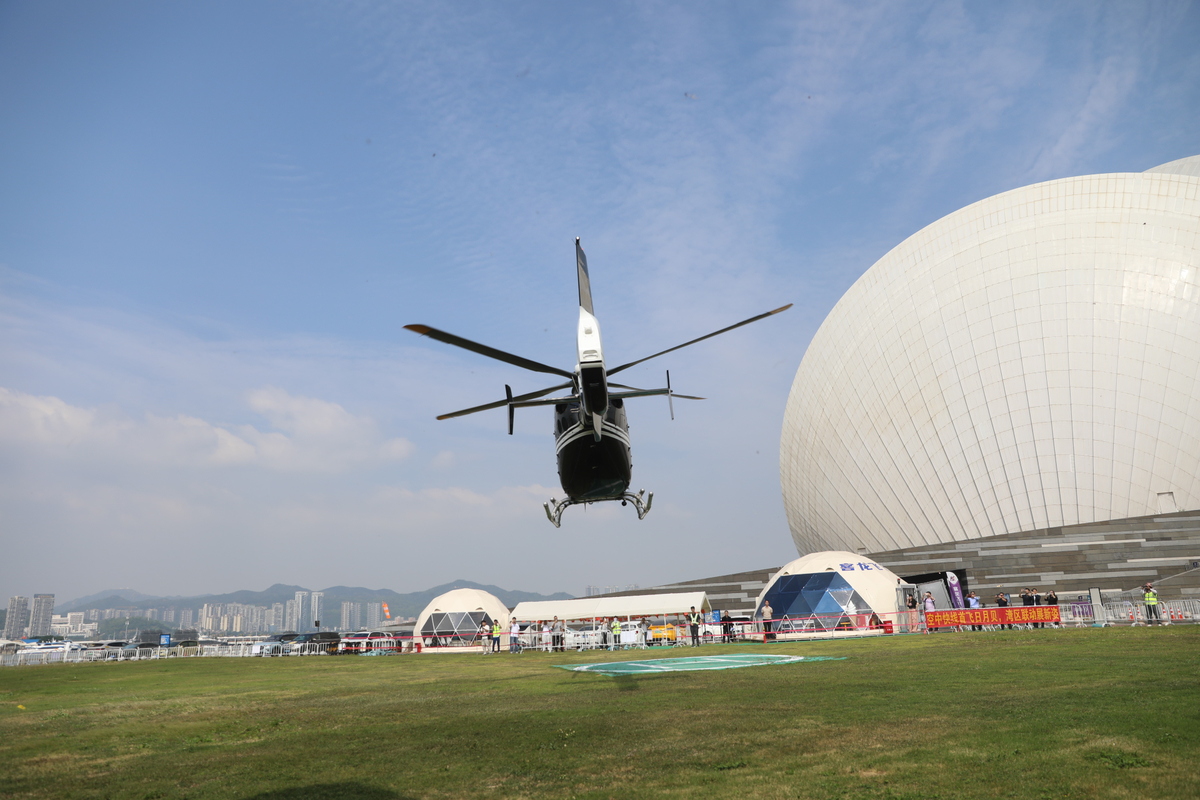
[{"left": 0, "top": 2, "right": 1200, "bottom": 599}]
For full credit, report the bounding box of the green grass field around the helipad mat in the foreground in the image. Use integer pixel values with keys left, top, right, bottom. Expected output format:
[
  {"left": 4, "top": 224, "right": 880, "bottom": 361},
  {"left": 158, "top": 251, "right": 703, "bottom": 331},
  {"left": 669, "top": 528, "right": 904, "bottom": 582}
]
[{"left": 0, "top": 626, "right": 1200, "bottom": 800}]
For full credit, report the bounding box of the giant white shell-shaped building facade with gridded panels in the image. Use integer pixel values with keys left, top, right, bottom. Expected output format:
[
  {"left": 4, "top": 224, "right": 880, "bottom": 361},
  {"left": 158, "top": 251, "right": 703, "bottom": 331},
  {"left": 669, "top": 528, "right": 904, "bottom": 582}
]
[{"left": 780, "top": 157, "right": 1200, "bottom": 553}]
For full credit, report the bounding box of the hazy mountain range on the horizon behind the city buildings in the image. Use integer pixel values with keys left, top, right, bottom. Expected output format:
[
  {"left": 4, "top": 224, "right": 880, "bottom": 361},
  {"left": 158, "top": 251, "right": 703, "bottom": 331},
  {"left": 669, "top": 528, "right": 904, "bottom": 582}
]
[{"left": 55, "top": 581, "right": 572, "bottom": 625}]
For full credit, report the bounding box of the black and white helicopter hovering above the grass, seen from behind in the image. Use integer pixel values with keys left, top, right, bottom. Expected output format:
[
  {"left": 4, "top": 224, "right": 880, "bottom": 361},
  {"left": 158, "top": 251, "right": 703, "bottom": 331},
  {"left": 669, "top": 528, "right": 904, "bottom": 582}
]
[{"left": 404, "top": 237, "right": 792, "bottom": 528}]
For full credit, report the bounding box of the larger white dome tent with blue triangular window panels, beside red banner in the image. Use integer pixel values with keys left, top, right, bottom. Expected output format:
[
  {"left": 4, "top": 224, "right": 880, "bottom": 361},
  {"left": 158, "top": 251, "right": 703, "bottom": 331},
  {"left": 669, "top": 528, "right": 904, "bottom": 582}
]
[{"left": 755, "top": 551, "right": 900, "bottom": 630}]
